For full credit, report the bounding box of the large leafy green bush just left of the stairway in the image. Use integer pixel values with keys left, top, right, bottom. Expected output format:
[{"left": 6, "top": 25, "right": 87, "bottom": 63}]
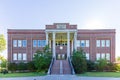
[{"left": 33, "top": 46, "right": 52, "bottom": 72}]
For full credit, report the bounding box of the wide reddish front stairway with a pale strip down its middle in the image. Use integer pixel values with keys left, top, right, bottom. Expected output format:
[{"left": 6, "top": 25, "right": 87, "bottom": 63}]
[{"left": 51, "top": 60, "right": 71, "bottom": 74}]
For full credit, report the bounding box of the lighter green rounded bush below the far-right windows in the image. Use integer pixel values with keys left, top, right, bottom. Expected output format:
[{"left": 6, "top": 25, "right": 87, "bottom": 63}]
[{"left": 96, "top": 59, "right": 107, "bottom": 71}]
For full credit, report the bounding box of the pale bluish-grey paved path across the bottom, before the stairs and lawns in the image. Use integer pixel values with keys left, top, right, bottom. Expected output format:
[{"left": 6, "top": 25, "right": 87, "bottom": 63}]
[{"left": 0, "top": 75, "right": 120, "bottom": 80}]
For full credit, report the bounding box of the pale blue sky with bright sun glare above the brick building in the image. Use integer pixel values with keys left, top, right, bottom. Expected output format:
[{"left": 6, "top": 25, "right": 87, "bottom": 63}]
[{"left": 0, "top": 0, "right": 120, "bottom": 56}]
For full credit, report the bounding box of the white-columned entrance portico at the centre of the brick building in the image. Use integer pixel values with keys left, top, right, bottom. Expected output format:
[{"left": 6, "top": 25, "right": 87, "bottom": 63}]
[{"left": 46, "top": 23, "right": 77, "bottom": 59}]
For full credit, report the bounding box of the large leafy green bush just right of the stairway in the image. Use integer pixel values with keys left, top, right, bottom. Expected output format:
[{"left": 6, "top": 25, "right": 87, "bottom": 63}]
[{"left": 72, "top": 49, "right": 87, "bottom": 74}]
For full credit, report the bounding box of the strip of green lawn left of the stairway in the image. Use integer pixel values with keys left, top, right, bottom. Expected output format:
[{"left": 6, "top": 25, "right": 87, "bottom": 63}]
[{"left": 0, "top": 72, "right": 46, "bottom": 77}]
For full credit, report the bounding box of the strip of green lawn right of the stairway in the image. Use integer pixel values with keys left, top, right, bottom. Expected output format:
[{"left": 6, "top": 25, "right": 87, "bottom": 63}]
[{"left": 77, "top": 72, "right": 120, "bottom": 77}]
